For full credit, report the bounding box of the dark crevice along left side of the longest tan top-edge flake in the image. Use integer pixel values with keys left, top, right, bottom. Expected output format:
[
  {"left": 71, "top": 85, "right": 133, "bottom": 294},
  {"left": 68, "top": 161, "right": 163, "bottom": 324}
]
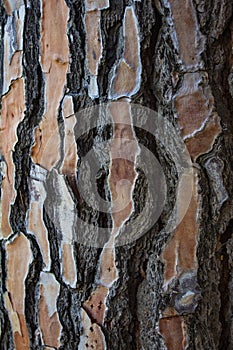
[{"left": 10, "top": 1, "right": 44, "bottom": 233}]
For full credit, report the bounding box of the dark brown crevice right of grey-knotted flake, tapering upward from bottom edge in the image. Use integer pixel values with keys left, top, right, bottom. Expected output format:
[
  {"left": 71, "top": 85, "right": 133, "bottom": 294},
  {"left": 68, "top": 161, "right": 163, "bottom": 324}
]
[{"left": 197, "top": 171, "right": 220, "bottom": 350}]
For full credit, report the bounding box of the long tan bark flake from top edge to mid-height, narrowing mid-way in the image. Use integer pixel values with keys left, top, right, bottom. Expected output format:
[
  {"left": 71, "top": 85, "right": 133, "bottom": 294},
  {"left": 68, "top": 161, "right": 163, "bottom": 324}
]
[{"left": 31, "top": 0, "right": 69, "bottom": 170}]
